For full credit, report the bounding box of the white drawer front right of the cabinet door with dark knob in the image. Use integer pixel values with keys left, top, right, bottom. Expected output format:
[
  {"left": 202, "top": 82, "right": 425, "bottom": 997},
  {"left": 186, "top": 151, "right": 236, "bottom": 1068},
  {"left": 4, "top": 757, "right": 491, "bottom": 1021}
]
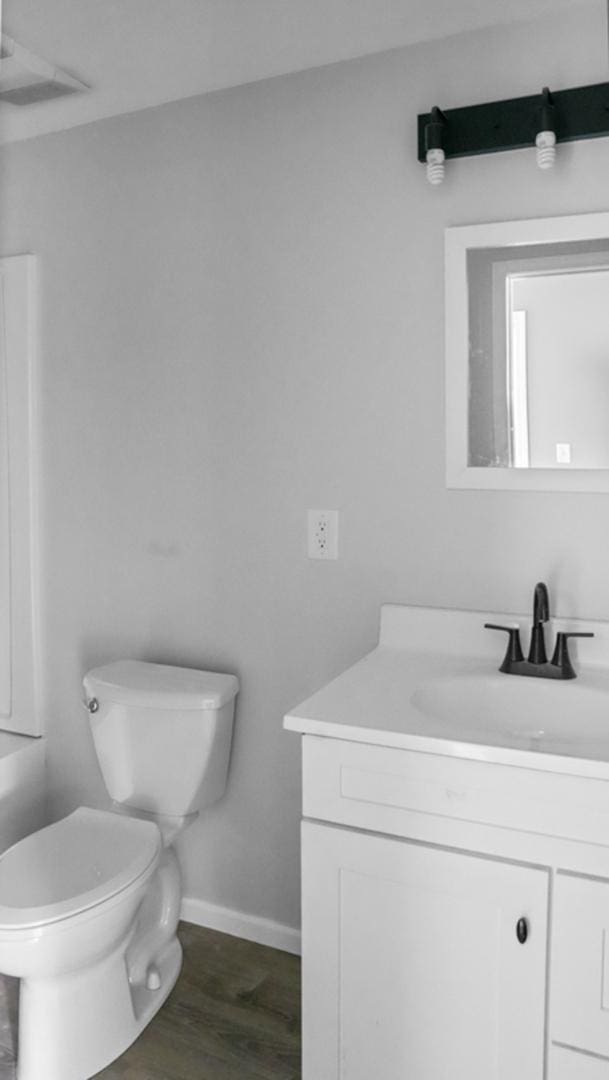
[{"left": 551, "top": 873, "right": 609, "bottom": 1054}]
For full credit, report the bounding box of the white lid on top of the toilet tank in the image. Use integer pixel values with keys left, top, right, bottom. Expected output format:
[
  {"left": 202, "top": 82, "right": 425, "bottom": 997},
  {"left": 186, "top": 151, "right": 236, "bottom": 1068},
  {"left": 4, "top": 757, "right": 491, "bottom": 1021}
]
[{"left": 83, "top": 660, "right": 239, "bottom": 710}]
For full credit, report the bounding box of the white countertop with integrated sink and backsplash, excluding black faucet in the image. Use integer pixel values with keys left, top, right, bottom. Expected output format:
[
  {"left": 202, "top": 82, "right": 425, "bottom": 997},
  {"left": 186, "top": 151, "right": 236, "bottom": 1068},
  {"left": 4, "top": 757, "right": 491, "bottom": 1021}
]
[{"left": 284, "top": 605, "right": 609, "bottom": 780}]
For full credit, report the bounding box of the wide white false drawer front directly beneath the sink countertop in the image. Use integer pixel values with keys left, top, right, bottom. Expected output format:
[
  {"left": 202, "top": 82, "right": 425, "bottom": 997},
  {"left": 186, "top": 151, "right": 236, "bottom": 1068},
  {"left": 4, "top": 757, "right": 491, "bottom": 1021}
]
[{"left": 302, "top": 735, "right": 609, "bottom": 845}]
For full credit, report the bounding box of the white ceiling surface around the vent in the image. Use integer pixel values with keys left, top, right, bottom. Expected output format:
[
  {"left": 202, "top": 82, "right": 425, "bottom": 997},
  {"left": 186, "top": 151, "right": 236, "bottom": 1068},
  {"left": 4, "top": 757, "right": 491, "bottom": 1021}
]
[{"left": 0, "top": 0, "right": 600, "bottom": 141}]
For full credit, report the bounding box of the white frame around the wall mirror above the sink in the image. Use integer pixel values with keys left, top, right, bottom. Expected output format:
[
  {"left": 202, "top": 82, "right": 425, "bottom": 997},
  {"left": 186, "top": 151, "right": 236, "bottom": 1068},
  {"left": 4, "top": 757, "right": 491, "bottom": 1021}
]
[{"left": 445, "top": 213, "right": 609, "bottom": 491}]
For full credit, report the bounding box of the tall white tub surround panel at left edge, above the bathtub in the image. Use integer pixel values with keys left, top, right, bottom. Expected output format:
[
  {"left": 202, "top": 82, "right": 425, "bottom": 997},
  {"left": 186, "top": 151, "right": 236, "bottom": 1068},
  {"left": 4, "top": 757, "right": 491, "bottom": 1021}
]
[{"left": 0, "top": 255, "right": 42, "bottom": 735}]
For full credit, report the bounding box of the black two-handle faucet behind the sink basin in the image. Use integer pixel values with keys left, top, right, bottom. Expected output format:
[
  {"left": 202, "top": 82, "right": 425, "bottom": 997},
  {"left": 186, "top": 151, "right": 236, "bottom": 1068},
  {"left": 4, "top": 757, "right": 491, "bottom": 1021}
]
[{"left": 485, "top": 581, "right": 594, "bottom": 678}]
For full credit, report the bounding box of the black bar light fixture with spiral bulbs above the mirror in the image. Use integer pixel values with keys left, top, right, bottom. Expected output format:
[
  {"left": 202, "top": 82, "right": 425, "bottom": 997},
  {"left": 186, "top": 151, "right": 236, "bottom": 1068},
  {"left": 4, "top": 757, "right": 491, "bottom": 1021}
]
[{"left": 418, "top": 82, "right": 609, "bottom": 185}]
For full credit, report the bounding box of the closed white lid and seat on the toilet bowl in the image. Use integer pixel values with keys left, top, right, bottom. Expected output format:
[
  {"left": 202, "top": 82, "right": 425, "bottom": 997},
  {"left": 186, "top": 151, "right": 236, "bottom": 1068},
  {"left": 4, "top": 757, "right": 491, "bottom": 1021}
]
[{"left": 0, "top": 807, "right": 161, "bottom": 930}]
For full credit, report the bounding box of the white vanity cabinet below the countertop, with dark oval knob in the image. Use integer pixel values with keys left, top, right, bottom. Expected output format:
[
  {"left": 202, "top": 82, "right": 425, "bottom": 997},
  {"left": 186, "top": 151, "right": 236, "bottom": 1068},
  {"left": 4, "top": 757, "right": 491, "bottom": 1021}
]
[{"left": 295, "top": 734, "right": 609, "bottom": 1080}]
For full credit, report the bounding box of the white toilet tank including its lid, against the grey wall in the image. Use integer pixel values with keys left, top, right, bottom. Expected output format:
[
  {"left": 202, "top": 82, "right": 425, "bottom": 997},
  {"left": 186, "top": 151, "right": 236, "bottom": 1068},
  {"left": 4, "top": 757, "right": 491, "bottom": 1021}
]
[{"left": 83, "top": 660, "right": 239, "bottom": 818}]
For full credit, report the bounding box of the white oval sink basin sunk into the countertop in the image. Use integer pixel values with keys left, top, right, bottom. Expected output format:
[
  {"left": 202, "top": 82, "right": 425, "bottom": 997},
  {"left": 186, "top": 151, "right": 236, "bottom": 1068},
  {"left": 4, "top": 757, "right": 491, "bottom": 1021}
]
[{"left": 410, "top": 673, "right": 609, "bottom": 756}]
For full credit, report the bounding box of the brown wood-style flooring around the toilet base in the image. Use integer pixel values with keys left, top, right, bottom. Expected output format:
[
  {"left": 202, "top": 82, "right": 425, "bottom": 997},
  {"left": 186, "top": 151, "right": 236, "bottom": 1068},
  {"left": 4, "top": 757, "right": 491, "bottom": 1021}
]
[{"left": 0, "top": 922, "right": 300, "bottom": 1080}]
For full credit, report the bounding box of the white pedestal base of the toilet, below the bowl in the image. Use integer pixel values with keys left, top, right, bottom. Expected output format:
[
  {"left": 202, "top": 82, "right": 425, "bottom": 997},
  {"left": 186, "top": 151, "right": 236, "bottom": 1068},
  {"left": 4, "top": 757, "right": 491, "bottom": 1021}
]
[{"left": 17, "top": 936, "right": 181, "bottom": 1080}]
